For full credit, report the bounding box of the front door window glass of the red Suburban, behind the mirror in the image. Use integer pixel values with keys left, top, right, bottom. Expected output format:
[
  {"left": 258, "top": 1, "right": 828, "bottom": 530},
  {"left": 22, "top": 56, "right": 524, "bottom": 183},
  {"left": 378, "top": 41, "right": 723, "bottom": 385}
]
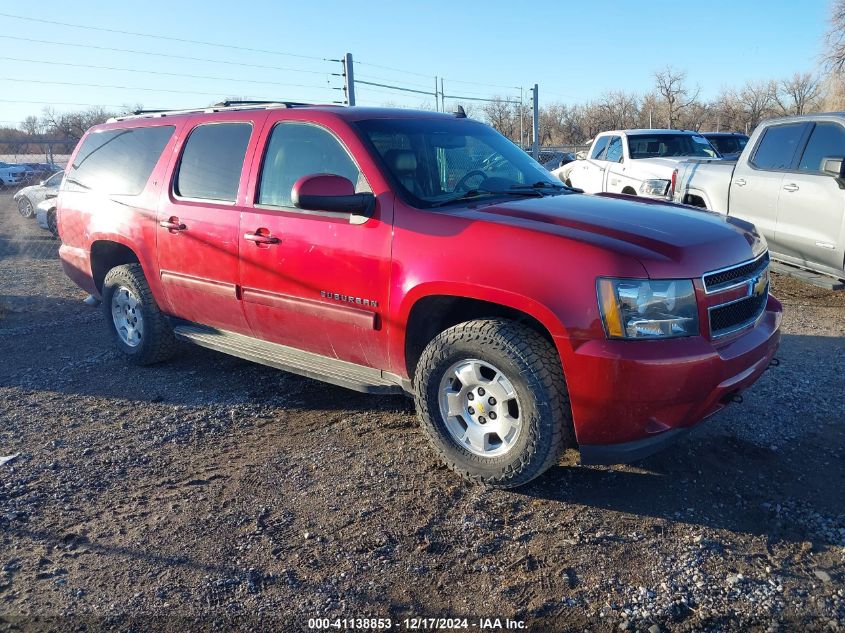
[{"left": 258, "top": 123, "right": 362, "bottom": 207}]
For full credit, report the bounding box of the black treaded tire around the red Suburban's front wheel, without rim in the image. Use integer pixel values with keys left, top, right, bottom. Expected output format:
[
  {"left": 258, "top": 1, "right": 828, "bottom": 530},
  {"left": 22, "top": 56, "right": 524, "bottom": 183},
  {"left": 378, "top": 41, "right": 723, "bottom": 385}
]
[{"left": 414, "top": 318, "right": 574, "bottom": 488}]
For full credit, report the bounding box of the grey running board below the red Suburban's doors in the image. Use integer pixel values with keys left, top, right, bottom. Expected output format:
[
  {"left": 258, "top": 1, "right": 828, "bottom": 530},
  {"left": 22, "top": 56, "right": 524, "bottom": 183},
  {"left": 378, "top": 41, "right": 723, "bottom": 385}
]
[{"left": 173, "top": 322, "right": 404, "bottom": 394}]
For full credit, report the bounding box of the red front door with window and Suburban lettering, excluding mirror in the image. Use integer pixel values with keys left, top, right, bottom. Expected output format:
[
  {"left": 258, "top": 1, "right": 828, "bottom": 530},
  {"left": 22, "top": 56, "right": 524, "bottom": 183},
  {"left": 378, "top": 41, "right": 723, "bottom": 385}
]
[{"left": 240, "top": 121, "right": 393, "bottom": 367}]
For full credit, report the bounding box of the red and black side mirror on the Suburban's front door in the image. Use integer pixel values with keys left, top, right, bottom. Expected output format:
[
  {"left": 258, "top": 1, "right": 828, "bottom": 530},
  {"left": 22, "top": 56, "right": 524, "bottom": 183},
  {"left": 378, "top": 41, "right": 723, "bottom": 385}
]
[{"left": 290, "top": 174, "right": 376, "bottom": 224}]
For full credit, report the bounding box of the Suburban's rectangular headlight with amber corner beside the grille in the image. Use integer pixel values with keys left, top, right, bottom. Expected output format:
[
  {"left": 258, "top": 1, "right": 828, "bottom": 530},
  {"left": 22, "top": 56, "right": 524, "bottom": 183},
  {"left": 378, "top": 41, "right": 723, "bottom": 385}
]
[{"left": 596, "top": 279, "right": 699, "bottom": 339}]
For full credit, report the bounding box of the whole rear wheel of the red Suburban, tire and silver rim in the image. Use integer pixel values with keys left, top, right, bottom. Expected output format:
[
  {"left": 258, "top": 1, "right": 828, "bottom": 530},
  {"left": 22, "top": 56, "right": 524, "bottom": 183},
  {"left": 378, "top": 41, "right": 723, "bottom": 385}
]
[{"left": 102, "top": 264, "right": 176, "bottom": 365}]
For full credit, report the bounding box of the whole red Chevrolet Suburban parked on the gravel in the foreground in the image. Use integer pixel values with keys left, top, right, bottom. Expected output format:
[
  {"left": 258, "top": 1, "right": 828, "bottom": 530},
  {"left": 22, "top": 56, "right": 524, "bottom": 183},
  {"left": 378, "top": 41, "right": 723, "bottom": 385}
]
[{"left": 58, "top": 103, "right": 781, "bottom": 487}]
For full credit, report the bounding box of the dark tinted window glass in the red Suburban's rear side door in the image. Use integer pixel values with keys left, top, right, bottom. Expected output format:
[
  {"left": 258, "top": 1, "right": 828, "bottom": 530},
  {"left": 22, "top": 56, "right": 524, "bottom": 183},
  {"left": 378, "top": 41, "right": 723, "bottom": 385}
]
[{"left": 175, "top": 123, "right": 252, "bottom": 202}]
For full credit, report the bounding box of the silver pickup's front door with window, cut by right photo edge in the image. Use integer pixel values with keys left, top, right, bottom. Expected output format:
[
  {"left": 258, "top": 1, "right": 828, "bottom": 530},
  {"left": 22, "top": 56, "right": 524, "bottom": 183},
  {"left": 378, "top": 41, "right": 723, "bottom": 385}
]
[{"left": 775, "top": 121, "right": 845, "bottom": 269}]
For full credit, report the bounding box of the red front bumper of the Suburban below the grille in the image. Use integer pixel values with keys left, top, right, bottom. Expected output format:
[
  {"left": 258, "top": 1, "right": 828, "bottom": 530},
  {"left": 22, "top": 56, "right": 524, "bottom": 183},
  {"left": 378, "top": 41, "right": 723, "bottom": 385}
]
[{"left": 564, "top": 296, "right": 782, "bottom": 463}]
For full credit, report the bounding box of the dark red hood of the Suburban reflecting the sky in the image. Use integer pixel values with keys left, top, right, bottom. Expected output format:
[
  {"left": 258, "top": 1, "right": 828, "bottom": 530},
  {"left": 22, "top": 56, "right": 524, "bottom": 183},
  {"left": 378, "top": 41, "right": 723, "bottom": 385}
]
[{"left": 462, "top": 194, "right": 766, "bottom": 279}]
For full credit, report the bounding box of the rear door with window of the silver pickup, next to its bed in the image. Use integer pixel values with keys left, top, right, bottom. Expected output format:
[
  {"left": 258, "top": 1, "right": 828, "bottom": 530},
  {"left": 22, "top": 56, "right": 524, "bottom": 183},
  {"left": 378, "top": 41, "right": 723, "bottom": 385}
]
[{"left": 729, "top": 122, "right": 808, "bottom": 241}]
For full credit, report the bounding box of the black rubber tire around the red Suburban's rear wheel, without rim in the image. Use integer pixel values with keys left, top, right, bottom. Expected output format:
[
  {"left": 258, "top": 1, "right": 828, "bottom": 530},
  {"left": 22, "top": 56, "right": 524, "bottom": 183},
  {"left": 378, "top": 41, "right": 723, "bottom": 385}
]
[{"left": 102, "top": 264, "right": 179, "bottom": 365}]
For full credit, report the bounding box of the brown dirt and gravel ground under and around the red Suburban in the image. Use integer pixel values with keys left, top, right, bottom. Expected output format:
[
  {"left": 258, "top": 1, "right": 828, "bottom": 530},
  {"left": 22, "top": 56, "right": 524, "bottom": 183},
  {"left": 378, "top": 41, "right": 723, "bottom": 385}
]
[{"left": 0, "top": 194, "right": 845, "bottom": 633}]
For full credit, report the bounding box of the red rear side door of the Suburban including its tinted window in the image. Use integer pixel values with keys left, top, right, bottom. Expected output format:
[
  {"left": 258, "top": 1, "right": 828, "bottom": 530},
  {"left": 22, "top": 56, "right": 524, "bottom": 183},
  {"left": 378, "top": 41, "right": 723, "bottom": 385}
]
[{"left": 157, "top": 119, "right": 264, "bottom": 333}]
